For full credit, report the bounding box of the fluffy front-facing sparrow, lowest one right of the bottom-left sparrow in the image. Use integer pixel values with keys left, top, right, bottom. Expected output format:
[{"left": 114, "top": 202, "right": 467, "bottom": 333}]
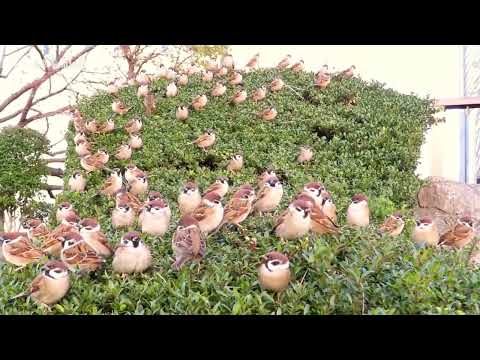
[{"left": 112, "top": 231, "right": 153, "bottom": 274}]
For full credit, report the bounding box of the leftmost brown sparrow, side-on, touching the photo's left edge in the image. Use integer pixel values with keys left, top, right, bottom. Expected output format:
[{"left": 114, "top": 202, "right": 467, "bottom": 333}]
[{"left": 0, "top": 232, "right": 43, "bottom": 270}]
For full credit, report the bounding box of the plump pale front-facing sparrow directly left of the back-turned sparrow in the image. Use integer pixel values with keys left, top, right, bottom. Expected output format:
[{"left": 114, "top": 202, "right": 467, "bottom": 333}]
[{"left": 139, "top": 200, "right": 172, "bottom": 236}]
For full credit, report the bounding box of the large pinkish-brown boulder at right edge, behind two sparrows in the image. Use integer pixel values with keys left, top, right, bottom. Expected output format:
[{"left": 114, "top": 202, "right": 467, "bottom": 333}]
[{"left": 415, "top": 177, "right": 480, "bottom": 235}]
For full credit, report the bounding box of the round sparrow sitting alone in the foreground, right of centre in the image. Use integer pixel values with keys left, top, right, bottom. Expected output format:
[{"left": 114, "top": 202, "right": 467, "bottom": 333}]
[{"left": 258, "top": 251, "right": 290, "bottom": 292}]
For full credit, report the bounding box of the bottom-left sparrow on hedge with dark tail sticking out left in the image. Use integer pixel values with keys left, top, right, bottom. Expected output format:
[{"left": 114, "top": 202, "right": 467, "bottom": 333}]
[{"left": 10, "top": 260, "right": 70, "bottom": 307}]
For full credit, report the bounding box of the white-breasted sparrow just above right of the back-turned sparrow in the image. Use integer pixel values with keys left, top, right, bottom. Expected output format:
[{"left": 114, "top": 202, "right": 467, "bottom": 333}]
[{"left": 191, "top": 191, "right": 223, "bottom": 234}]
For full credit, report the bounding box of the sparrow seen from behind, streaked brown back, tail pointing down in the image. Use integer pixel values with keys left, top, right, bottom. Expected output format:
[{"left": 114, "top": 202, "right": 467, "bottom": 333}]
[{"left": 172, "top": 214, "right": 206, "bottom": 270}]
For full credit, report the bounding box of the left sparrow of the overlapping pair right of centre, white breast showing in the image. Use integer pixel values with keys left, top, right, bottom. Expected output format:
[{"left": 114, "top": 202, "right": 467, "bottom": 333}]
[{"left": 273, "top": 200, "right": 311, "bottom": 240}]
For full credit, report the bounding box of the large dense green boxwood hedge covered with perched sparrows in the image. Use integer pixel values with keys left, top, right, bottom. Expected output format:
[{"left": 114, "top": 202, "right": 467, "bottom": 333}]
[{"left": 0, "top": 69, "right": 480, "bottom": 314}]
